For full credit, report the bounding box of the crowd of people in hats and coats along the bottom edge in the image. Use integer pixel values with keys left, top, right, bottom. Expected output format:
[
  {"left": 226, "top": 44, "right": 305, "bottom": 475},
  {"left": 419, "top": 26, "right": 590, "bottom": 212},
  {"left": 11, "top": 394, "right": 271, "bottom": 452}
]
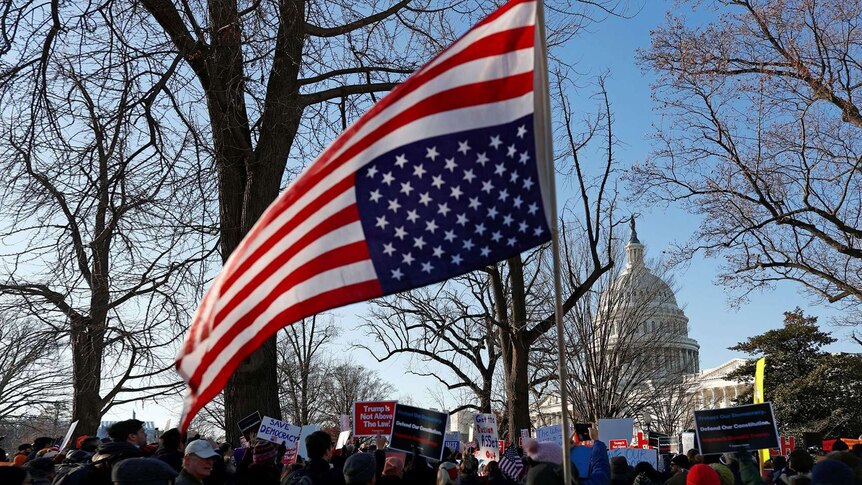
[{"left": 0, "top": 419, "right": 862, "bottom": 485}]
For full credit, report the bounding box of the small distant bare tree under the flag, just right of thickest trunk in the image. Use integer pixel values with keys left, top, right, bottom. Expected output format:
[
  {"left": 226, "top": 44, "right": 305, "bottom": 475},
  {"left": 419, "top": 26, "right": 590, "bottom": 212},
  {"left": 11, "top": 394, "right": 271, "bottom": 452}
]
[{"left": 278, "top": 314, "right": 338, "bottom": 424}]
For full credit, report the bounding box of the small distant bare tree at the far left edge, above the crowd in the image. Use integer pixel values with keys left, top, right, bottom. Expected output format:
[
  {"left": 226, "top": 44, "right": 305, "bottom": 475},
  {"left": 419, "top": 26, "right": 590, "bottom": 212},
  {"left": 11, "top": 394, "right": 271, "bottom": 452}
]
[{"left": 0, "top": 314, "right": 69, "bottom": 428}]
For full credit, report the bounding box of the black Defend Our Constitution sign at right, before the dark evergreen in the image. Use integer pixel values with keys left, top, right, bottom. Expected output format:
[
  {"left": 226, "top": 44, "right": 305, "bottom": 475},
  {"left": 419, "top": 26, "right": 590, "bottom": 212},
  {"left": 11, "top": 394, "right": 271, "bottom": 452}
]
[{"left": 694, "top": 402, "right": 778, "bottom": 455}]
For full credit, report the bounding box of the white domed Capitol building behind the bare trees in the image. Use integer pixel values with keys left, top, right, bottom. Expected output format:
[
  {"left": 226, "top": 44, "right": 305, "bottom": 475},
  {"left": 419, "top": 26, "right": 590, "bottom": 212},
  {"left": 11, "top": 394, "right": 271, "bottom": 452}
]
[{"left": 532, "top": 221, "right": 748, "bottom": 433}]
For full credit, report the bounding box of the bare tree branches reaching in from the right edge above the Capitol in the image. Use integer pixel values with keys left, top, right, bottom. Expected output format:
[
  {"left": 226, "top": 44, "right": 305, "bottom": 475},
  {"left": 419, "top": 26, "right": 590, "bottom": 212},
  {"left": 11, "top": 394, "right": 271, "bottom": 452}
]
[{"left": 633, "top": 0, "right": 862, "bottom": 330}]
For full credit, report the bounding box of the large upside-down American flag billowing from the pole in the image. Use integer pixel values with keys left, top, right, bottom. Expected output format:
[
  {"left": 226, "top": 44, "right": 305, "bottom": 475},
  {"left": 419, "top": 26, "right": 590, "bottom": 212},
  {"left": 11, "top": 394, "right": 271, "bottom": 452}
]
[{"left": 176, "top": 0, "right": 551, "bottom": 429}]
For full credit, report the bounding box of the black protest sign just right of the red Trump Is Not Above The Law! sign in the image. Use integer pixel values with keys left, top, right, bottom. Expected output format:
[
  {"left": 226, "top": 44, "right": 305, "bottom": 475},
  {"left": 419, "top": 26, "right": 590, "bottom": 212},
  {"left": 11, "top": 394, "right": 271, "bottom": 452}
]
[{"left": 389, "top": 404, "right": 449, "bottom": 460}]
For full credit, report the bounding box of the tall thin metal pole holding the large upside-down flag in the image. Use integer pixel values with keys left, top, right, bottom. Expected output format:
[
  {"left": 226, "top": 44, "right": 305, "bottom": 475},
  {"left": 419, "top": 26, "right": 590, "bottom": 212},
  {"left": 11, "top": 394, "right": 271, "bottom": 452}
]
[{"left": 535, "top": 0, "right": 572, "bottom": 485}]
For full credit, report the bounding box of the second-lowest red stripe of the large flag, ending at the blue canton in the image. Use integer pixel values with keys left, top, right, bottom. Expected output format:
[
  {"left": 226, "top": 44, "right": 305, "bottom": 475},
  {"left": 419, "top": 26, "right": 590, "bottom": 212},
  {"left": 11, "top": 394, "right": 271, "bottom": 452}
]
[{"left": 188, "top": 238, "right": 372, "bottom": 389}]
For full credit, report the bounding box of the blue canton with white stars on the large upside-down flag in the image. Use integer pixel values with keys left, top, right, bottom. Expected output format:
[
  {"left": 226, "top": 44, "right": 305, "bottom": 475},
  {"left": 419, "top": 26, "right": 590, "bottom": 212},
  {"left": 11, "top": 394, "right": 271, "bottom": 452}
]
[{"left": 356, "top": 115, "right": 551, "bottom": 293}]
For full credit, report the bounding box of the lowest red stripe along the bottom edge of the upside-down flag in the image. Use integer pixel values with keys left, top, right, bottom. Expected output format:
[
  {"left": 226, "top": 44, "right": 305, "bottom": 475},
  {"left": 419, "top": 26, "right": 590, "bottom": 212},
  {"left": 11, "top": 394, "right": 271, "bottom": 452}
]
[{"left": 180, "top": 281, "right": 383, "bottom": 430}]
